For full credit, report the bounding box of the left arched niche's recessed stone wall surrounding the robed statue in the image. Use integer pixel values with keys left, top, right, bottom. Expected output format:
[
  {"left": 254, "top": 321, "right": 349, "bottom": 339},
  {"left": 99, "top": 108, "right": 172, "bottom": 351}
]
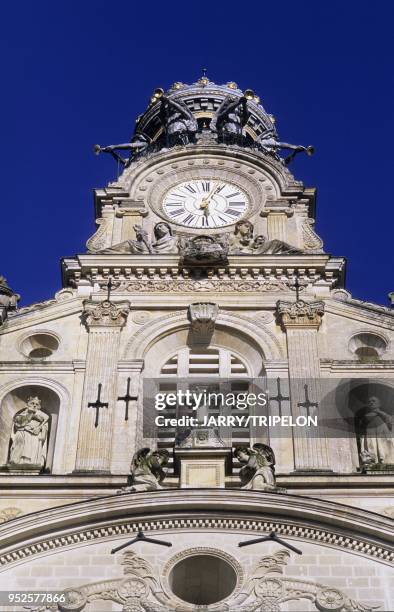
[{"left": 0, "top": 384, "right": 60, "bottom": 472}]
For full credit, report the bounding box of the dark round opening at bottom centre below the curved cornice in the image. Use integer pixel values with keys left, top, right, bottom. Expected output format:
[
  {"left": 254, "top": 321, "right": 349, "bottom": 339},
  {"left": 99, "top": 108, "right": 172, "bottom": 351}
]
[{"left": 169, "top": 555, "right": 237, "bottom": 606}]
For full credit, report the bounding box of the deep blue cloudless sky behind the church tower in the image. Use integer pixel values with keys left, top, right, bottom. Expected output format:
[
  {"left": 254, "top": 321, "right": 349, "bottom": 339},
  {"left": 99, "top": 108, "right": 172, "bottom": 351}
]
[{"left": 0, "top": 0, "right": 394, "bottom": 304}]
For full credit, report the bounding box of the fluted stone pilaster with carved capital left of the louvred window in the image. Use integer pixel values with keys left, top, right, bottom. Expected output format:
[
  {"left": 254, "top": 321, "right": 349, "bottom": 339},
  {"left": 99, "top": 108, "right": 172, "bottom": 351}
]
[{"left": 75, "top": 300, "right": 129, "bottom": 472}]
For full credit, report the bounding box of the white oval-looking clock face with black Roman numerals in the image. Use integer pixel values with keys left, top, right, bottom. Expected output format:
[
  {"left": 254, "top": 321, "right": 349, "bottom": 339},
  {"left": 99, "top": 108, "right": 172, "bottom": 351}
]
[{"left": 163, "top": 179, "right": 249, "bottom": 229}]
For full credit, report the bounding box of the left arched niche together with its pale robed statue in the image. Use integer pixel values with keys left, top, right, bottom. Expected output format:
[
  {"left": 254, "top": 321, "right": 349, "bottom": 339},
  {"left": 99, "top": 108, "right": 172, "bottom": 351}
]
[{"left": 0, "top": 385, "right": 60, "bottom": 472}]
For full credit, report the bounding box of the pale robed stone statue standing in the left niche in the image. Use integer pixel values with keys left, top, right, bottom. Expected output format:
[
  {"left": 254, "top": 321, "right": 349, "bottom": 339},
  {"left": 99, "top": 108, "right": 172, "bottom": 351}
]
[{"left": 8, "top": 397, "right": 49, "bottom": 468}]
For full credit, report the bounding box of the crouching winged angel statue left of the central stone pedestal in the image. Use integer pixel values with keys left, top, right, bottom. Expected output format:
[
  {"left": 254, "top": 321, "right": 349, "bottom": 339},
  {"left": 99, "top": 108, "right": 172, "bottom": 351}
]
[{"left": 119, "top": 448, "right": 170, "bottom": 493}]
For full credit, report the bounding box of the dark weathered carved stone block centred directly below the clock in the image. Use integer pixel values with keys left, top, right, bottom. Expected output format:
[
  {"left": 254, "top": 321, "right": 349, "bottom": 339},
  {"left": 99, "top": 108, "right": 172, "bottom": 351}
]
[{"left": 178, "top": 234, "right": 228, "bottom": 265}]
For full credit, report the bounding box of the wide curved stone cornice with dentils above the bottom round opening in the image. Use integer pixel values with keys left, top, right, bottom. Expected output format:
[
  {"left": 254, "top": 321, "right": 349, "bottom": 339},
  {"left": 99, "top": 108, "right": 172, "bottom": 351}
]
[{"left": 0, "top": 489, "right": 394, "bottom": 566}]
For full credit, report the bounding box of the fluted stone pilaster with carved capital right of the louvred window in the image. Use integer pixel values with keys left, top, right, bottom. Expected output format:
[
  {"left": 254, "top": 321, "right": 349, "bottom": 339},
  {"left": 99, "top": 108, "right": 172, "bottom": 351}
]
[{"left": 277, "top": 300, "right": 330, "bottom": 471}]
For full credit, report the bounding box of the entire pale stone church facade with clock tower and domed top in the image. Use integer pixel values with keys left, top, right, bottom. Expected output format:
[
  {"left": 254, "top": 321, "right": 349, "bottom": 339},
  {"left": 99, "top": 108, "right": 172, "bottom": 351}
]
[{"left": 0, "top": 76, "right": 394, "bottom": 612}]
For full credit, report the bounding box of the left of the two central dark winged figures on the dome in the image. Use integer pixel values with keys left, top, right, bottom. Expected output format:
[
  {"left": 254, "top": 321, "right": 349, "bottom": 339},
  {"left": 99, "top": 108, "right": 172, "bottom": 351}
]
[{"left": 160, "top": 96, "right": 198, "bottom": 146}]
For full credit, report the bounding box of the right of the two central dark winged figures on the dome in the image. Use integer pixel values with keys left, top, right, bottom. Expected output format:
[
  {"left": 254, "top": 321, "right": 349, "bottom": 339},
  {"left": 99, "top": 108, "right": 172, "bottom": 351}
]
[{"left": 210, "top": 96, "right": 250, "bottom": 143}]
